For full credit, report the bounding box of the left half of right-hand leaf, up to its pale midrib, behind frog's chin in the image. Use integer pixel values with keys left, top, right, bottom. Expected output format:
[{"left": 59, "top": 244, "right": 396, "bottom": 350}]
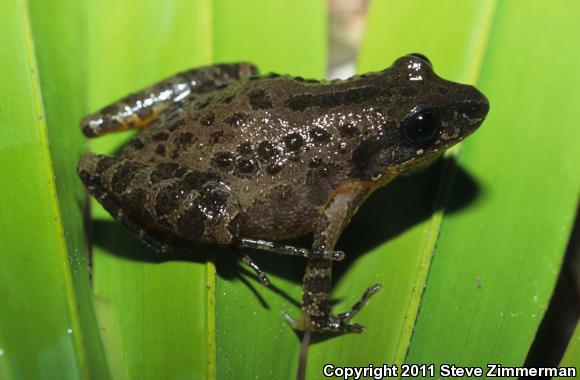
[{"left": 309, "top": 0, "right": 494, "bottom": 377}]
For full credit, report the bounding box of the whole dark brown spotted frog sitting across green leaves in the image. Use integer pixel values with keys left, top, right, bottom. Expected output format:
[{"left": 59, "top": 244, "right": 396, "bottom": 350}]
[{"left": 77, "top": 53, "right": 489, "bottom": 334}]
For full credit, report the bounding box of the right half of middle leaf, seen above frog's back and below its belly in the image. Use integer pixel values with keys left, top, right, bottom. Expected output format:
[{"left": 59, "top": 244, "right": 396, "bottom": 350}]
[{"left": 214, "top": 0, "right": 326, "bottom": 379}]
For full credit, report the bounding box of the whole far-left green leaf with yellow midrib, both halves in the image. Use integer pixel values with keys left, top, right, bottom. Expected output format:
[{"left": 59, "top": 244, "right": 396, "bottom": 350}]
[{"left": 0, "top": 0, "right": 108, "bottom": 379}]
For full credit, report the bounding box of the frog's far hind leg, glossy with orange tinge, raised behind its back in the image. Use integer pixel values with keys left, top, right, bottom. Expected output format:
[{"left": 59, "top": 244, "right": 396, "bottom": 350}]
[{"left": 81, "top": 63, "right": 258, "bottom": 137}]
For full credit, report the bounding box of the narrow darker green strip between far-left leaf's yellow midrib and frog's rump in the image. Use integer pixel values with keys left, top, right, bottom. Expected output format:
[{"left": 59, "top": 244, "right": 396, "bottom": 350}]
[{"left": 29, "top": 0, "right": 108, "bottom": 379}]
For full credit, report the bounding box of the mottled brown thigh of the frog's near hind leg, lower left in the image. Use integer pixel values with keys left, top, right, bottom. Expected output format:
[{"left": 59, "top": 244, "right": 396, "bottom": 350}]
[{"left": 77, "top": 153, "right": 239, "bottom": 250}]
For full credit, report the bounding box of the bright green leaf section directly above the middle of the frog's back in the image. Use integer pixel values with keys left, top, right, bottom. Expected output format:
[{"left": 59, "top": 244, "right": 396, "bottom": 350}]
[{"left": 213, "top": 0, "right": 327, "bottom": 78}]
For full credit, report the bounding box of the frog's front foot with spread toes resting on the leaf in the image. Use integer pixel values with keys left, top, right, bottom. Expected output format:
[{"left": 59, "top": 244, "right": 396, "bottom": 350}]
[{"left": 283, "top": 284, "right": 381, "bottom": 334}]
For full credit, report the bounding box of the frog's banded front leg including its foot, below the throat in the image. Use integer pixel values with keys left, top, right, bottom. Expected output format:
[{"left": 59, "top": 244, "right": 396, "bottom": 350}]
[{"left": 286, "top": 183, "right": 380, "bottom": 333}]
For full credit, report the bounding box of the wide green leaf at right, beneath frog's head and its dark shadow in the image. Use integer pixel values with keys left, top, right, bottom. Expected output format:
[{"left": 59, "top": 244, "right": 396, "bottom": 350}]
[{"left": 309, "top": 0, "right": 580, "bottom": 377}]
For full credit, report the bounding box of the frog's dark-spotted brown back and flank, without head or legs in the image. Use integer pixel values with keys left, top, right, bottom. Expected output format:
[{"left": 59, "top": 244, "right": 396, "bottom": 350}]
[{"left": 124, "top": 75, "right": 388, "bottom": 238}]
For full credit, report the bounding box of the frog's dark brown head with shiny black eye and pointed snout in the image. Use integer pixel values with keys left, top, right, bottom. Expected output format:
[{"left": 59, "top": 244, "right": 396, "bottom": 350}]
[{"left": 360, "top": 54, "right": 489, "bottom": 182}]
